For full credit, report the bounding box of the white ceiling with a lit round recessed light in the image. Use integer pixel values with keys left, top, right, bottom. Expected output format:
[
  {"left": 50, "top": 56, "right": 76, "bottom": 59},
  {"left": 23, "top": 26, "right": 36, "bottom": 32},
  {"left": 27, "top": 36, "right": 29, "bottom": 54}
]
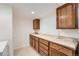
[{"left": 0, "top": 3, "right": 62, "bottom": 19}]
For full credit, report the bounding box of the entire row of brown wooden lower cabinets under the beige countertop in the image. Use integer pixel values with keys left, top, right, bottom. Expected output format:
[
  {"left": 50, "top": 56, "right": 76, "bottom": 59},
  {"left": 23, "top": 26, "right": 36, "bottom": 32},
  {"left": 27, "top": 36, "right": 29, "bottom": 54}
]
[{"left": 30, "top": 35, "right": 75, "bottom": 56}]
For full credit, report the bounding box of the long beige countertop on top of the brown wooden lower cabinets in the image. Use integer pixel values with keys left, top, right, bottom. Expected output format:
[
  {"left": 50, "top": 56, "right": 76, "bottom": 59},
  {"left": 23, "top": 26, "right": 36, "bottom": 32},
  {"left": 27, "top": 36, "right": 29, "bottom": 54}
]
[{"left": 31, "top": 34, "right": 78, "bottom": 50}]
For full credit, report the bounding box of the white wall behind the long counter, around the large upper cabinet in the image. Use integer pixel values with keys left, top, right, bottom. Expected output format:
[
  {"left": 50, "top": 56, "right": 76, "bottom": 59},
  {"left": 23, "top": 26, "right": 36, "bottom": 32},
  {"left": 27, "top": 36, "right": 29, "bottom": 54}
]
[{"left": 40, "top": 6, "right": 79, "bottom": 39}]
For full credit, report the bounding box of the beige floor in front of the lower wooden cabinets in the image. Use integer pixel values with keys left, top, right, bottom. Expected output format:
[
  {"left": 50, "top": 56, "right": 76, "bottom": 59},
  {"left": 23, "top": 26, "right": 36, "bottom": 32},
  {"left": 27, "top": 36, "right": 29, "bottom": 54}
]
[{"left": 14, "top": 46, "right": 40, "bottom": 56}]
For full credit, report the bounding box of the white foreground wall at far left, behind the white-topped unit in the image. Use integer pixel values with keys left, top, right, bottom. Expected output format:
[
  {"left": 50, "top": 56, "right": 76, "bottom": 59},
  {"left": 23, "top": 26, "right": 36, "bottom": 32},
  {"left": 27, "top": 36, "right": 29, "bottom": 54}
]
[{"left": 0, "top": 5, "right": 13, "bottom": 55}]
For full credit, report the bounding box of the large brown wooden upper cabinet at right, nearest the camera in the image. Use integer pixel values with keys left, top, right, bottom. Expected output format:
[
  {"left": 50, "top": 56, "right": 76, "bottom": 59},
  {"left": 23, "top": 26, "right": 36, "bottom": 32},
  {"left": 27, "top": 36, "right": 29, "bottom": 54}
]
[{"left": 56, "top": 3, "right": 78, "bottom": 29}]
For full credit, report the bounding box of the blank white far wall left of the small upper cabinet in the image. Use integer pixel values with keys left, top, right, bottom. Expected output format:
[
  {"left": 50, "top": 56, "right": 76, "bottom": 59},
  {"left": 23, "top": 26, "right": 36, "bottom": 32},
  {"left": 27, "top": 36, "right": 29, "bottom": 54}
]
[{"left": 13, "top": 7, "right": 33, "bottom": 49}]
